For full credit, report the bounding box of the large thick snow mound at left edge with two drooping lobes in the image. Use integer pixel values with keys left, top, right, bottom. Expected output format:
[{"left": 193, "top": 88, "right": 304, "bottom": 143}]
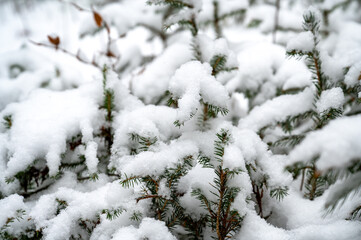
[{"left": 1, "top": 84, "right": 98, "bottom": 176}]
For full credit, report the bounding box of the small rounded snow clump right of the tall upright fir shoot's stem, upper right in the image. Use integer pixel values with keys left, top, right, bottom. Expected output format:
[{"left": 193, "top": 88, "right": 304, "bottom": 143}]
[{"left": 316, "top": 87, "right": 345, "bottom": 113}]
